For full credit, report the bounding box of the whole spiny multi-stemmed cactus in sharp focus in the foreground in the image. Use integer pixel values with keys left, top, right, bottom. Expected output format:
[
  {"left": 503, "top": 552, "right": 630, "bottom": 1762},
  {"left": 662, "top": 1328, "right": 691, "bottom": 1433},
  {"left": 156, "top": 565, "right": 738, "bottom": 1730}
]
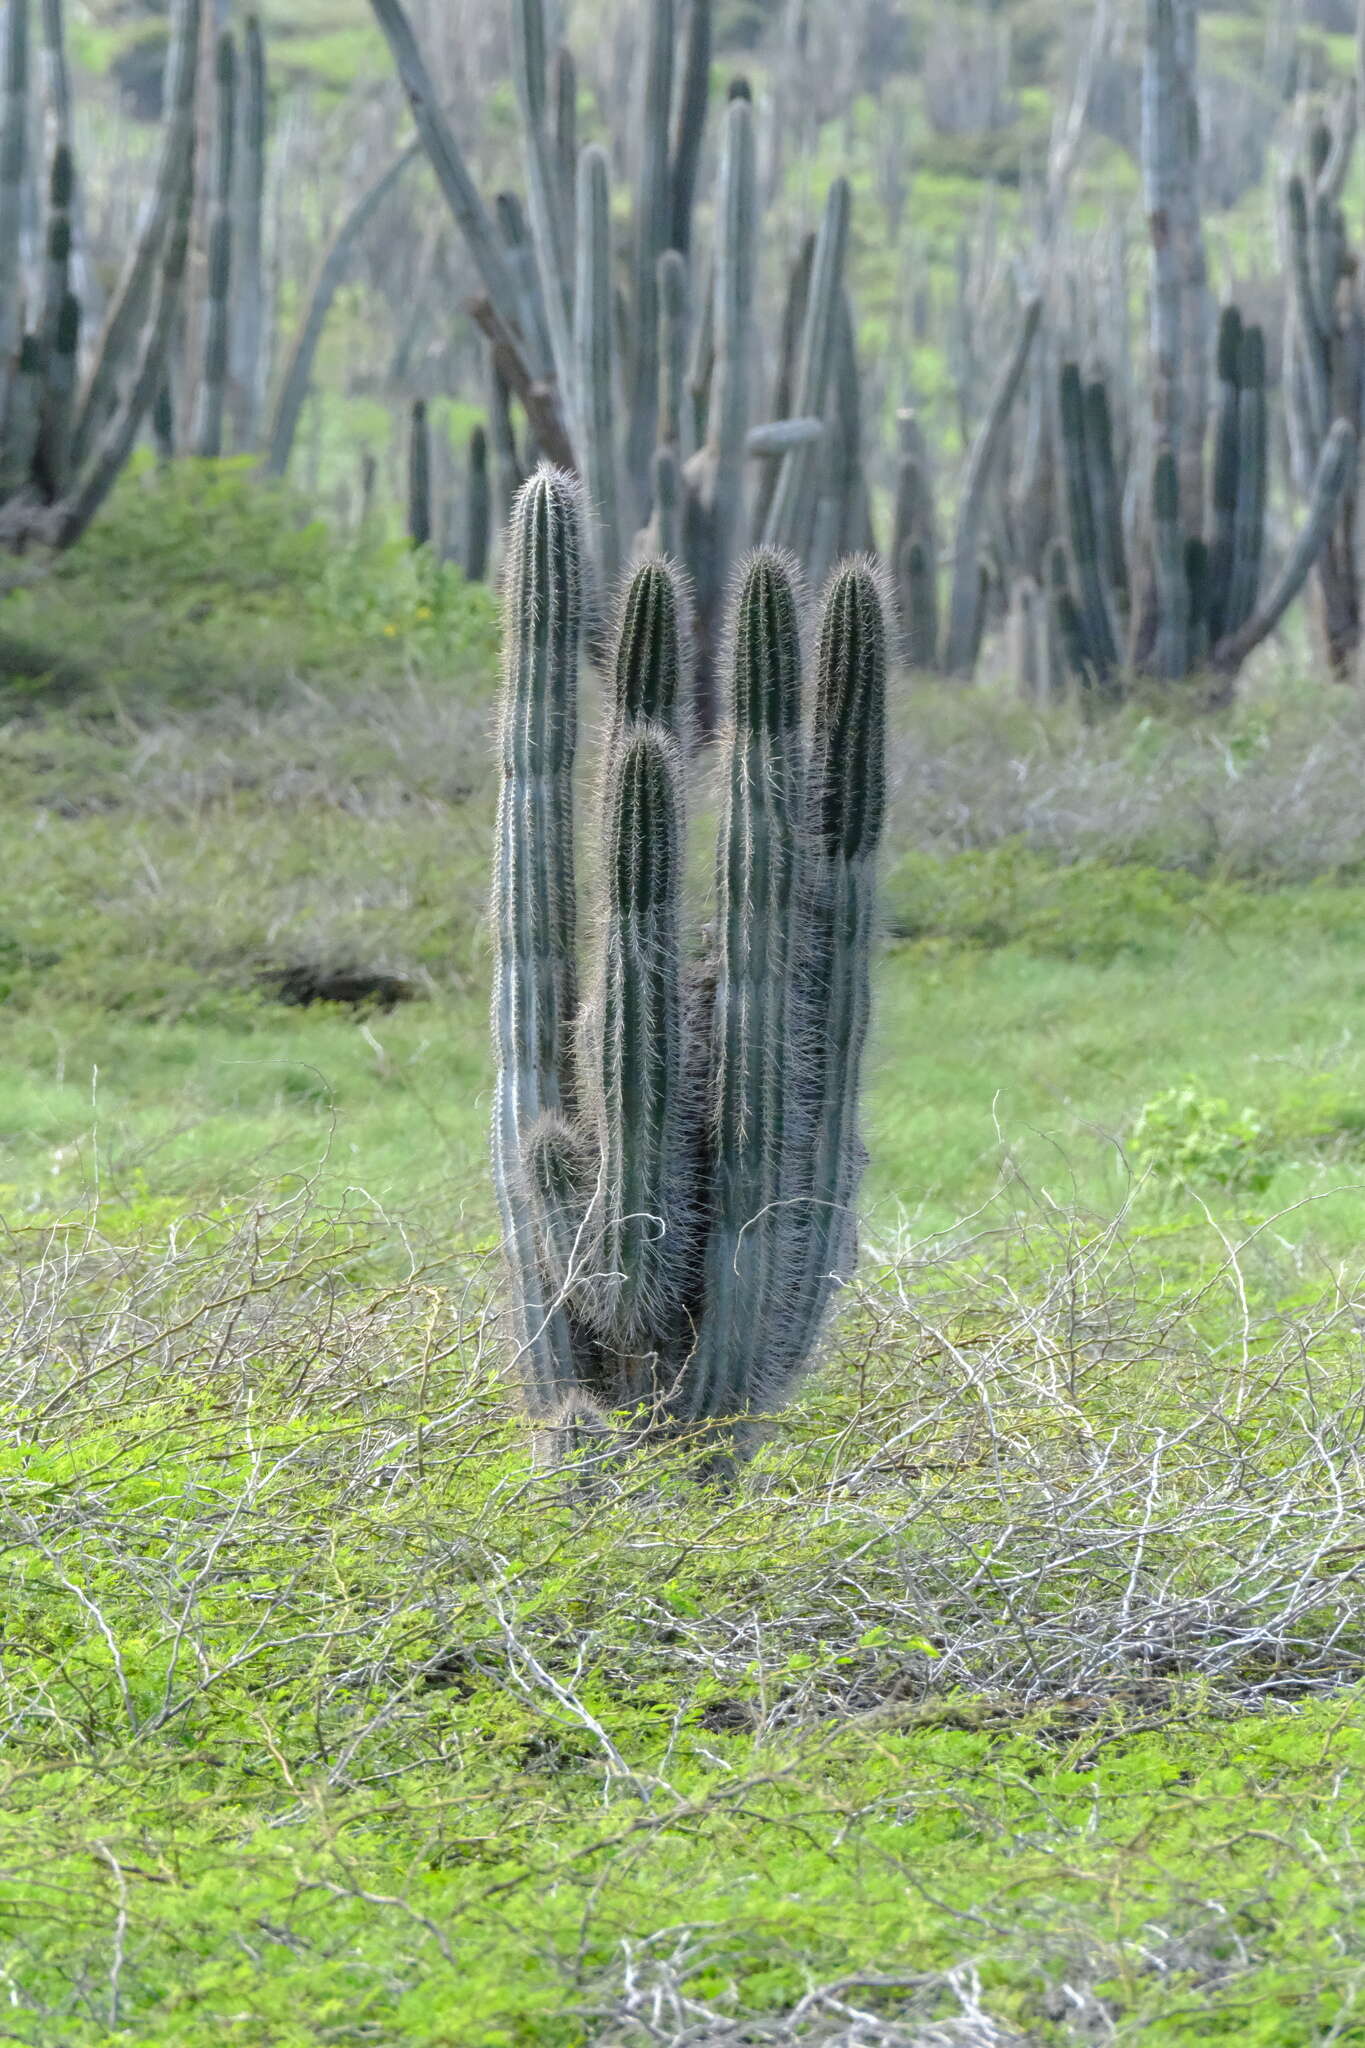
[{"left": 493, "top": 465, "right": 886, "bottom": 1456}]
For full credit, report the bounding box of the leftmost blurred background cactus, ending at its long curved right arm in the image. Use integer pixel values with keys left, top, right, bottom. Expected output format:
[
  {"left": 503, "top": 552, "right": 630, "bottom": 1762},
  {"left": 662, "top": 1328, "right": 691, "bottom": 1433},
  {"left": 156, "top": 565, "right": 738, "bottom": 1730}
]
[{"left": 0, "top": 0, "right": 201, "bottom": 549}]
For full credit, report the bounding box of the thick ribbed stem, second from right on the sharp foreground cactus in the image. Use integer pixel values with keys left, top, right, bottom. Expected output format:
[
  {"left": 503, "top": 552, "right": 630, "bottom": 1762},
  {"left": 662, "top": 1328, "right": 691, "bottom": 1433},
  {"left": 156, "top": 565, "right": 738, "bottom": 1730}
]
[{"left": 684, "top": 549, "right": 804, "bottom": 1419}]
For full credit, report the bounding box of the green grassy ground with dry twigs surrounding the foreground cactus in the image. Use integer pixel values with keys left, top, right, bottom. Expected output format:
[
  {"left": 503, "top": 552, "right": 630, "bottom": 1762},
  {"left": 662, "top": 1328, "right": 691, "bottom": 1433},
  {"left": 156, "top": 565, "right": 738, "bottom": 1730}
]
[{"left": 0, "top": 465, "right": 1365, "bottom": 2048}]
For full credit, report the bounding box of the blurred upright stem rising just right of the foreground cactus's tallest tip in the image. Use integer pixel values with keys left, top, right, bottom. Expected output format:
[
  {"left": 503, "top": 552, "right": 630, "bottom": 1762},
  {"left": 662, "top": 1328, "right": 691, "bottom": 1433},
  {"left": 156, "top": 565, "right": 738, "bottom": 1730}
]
[{"left": 573, "top": 143, "right": 620, "bottom": 594}]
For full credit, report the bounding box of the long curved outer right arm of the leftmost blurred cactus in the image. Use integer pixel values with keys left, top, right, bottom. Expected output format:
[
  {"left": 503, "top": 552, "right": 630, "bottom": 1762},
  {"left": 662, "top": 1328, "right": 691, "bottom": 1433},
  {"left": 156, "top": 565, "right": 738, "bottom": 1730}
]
[{"left": 72, "top": 0, "right": 203, "bottom": 469}]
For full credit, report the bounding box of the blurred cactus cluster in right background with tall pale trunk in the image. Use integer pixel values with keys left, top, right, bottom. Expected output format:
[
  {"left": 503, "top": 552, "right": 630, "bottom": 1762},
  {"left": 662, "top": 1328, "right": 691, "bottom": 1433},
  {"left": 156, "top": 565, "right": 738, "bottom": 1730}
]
[{"left": 1046, "top": 0, "right": 1355, "bottom": 700}]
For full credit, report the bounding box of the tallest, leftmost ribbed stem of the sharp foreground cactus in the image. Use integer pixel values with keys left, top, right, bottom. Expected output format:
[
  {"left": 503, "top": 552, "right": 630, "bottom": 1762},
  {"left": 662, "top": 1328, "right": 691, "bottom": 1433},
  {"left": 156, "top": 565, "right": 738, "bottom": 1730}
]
[{"left": 493, "top": 465, "right": 581, "bottom": 1417}]
